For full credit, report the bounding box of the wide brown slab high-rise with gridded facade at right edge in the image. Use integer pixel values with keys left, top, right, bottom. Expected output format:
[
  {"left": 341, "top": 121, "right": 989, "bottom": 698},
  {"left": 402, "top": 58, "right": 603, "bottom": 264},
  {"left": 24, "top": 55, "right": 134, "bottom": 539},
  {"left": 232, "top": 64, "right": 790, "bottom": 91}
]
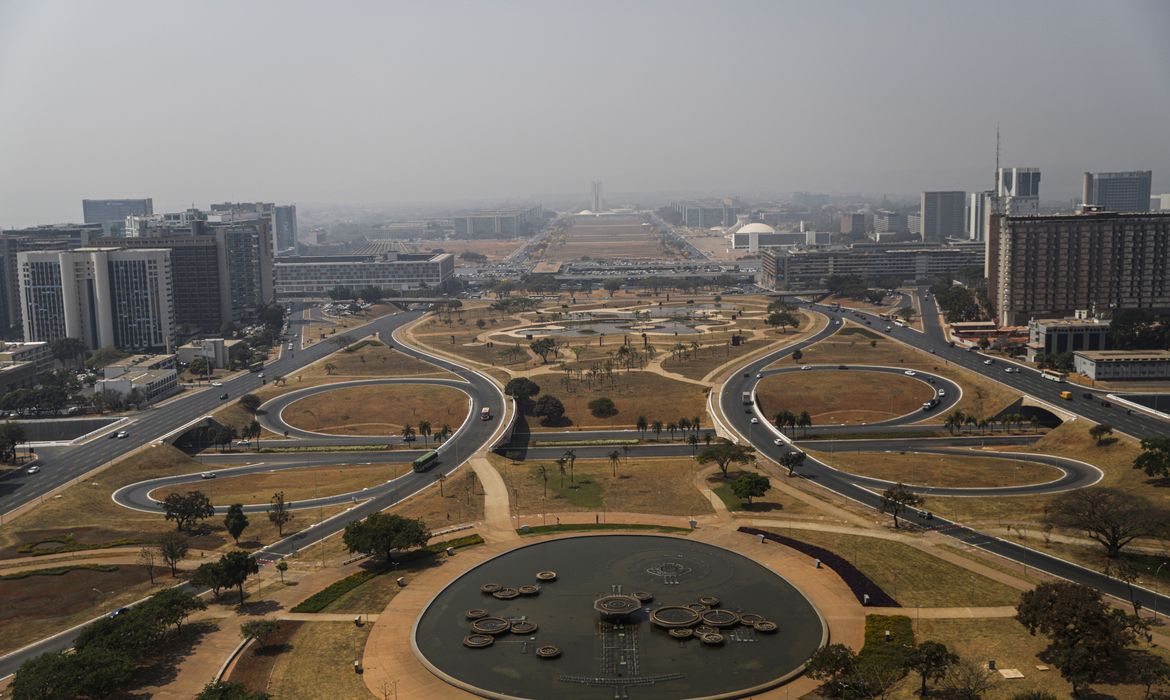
[{"left": 987, "top": 212, "right": 1170, "bottom": 327}]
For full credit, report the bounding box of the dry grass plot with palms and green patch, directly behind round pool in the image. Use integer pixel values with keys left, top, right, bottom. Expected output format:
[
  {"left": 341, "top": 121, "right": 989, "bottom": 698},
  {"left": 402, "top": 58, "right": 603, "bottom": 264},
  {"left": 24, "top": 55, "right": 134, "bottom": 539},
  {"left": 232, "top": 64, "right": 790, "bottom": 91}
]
[{"left": 493, "top": 458, "right": 713, "bottom": 517}]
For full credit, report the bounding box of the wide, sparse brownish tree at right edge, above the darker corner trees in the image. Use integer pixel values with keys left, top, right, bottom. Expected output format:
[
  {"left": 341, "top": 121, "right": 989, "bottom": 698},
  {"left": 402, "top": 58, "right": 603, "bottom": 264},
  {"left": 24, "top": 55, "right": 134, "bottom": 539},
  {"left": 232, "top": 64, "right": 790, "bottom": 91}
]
[{"left": 1045, "top": 488, "right": 1168, "bottom": 560}]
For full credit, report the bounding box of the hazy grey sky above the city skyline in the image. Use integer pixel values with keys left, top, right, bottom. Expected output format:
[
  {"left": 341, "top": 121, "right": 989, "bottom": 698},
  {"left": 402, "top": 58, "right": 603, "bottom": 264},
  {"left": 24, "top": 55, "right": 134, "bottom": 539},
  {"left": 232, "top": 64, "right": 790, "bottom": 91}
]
[{"left": 0, "top": 0, "right": 1170, "bottom": 226}]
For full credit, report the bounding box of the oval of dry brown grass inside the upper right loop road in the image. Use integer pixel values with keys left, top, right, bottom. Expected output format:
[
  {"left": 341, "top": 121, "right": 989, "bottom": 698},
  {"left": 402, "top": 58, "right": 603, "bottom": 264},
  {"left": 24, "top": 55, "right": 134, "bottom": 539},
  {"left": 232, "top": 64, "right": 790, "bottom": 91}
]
[{"left": 756, "top": 370, "right": 935, "bottom": 425}]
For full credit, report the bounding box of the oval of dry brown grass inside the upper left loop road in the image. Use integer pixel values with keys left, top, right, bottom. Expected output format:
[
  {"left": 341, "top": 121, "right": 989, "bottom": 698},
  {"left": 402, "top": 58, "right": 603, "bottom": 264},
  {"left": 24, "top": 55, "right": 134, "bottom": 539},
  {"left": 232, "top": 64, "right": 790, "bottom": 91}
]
[{"left": 282, "top": 384, "right": 468, "bottom": 439}]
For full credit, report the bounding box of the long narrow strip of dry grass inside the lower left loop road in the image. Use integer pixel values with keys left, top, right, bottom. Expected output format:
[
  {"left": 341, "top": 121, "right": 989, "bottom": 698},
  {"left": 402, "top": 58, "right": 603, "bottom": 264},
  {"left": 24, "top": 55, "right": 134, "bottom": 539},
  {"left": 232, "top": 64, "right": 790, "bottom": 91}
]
[{"left": 151, "top": 465, "right": 411, "bottom": 503}]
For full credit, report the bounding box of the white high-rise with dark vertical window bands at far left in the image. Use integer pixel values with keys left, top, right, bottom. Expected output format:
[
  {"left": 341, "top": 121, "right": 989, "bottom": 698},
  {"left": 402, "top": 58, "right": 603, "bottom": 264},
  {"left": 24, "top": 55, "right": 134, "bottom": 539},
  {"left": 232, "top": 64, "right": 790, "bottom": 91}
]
[{"left": 18, "top": 248, "right": 174, "bottom": 352}]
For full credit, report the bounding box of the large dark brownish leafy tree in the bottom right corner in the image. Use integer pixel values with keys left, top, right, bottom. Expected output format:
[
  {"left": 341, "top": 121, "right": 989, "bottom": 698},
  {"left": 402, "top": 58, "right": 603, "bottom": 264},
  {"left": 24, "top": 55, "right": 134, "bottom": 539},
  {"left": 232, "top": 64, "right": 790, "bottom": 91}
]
[{"left": 1016, "top": 581, "right": 1134, "bottom": 695}]
